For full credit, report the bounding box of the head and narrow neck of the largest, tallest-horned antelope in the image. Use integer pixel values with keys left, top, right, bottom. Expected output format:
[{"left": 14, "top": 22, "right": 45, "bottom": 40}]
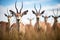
[{"left": 9, "top": 1, "right": 28, "bottom": 32}]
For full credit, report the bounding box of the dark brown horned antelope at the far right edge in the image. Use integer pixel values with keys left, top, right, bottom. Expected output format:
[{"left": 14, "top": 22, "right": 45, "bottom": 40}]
[{"left": 52, "top": 9, "right": 60, "bottom": 40}]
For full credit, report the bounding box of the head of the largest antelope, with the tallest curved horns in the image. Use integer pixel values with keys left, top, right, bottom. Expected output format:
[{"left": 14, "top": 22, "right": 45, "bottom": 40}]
[{"left": 9, "top": 1, "right": 28, "bottom": 19}]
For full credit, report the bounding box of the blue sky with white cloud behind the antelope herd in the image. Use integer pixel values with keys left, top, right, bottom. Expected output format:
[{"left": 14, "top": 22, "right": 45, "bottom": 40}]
[{"left": 0, "top": 0, "right": 60, "bottom": 24}]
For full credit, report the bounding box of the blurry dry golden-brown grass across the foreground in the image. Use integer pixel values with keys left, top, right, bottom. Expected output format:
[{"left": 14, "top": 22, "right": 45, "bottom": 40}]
[{"left": 0, "top": 26, "right": 60, "bottom": 40}]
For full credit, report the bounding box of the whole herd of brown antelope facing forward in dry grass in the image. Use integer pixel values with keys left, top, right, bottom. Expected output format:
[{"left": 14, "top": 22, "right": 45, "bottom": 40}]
[{"left": 0, "top": 2, "right": 60, "bottom": 37}]
